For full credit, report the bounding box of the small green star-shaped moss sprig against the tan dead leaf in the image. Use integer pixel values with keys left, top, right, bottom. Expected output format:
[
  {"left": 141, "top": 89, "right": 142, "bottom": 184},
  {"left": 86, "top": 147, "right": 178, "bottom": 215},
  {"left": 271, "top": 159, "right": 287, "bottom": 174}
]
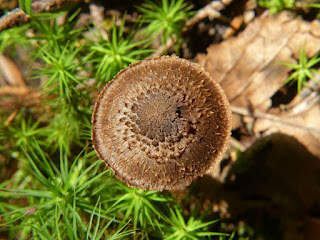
[{"left": 281, "top": 48, "right": 320, "bottom": 93}]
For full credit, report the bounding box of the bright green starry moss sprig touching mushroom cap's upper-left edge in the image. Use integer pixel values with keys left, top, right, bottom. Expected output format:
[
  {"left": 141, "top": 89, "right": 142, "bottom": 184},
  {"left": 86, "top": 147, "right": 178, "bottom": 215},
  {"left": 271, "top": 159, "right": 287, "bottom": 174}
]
[{"left": 87, "top": 17, "right": 152, "bottom": 85}]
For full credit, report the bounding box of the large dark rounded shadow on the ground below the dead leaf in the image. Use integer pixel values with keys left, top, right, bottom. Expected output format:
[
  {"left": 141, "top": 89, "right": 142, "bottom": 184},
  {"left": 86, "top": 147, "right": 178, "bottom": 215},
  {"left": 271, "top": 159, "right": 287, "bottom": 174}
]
[{"left": 194, "top": 134, "right": 320, "bottom": 240}]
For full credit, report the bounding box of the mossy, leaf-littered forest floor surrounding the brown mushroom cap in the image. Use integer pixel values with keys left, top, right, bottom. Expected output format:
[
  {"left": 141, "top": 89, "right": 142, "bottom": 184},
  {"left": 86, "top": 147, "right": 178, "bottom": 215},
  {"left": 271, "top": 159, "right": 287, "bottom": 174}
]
[{"left": 0, "top": 0, "right": 320, "bottom": 240}]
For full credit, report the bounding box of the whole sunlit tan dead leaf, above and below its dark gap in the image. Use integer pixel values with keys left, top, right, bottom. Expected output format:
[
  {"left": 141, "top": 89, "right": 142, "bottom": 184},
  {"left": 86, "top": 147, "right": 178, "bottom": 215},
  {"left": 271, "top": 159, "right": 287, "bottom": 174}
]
[{"left": 197, "top": 12, "right": 320, "bottom": 158}]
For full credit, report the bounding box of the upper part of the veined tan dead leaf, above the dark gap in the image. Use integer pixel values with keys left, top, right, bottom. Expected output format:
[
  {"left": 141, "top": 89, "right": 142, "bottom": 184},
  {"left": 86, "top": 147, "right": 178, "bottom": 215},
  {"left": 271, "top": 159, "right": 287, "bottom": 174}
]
[{"left": 196, "top": 12, "right": 320, "bottom": 111}]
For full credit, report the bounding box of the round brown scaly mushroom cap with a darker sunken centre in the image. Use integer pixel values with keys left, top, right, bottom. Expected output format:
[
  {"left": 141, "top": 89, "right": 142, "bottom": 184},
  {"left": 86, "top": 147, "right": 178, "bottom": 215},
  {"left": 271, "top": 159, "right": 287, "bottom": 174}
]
[{"left": 92, "top": 56, "right": 231, "bottom": 191}]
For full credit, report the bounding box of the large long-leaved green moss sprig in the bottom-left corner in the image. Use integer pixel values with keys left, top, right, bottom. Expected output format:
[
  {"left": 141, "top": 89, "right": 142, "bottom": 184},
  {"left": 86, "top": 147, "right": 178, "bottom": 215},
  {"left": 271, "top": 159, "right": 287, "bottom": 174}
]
[{"left": 0, "top": 144, "right": 112, "bottom": 239}]
